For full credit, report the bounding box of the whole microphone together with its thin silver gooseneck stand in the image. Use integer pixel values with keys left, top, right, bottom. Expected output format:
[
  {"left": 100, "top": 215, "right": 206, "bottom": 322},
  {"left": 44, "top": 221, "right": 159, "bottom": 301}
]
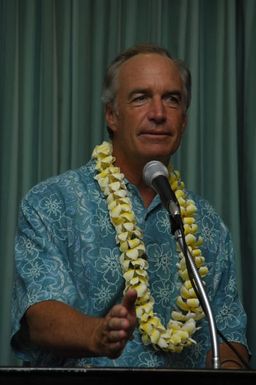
[{"left": 143, "top": 160, "right": 220, "bottom": 369}]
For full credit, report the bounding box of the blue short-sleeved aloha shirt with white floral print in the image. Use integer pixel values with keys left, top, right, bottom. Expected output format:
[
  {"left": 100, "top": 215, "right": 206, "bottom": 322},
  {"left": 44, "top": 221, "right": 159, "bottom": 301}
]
[{"left": 12, "top": 155, "right": 247, "bottom": 368}]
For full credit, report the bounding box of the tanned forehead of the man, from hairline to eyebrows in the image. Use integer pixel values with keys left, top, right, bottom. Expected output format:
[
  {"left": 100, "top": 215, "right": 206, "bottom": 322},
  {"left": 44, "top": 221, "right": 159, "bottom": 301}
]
[{"left": 119, "top": 53, "right": 182, "bottom": 87}]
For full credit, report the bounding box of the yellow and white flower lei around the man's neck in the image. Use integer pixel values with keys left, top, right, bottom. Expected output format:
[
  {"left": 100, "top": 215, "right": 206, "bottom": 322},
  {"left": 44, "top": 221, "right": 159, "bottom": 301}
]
[{"left": 92, "top": 142, "right": 208, "bottom": 352}]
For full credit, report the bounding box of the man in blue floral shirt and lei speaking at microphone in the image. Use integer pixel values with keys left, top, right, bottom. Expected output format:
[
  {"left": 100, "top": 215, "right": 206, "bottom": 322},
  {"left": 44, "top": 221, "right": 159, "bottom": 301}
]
[{"left": 12, "top": 45, "right": 248, "bottom": 368}]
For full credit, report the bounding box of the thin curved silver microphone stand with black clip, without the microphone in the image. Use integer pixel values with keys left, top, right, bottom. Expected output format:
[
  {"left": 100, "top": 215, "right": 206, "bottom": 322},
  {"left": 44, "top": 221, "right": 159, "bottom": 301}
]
[{"left": 168, "top": 200, "right": 220, "bottom": 369}]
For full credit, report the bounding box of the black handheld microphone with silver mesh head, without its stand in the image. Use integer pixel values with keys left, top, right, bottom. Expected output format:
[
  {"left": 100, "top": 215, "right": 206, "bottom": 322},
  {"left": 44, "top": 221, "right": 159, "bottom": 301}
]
[{"left": 143, "top": 160, "right": 181, "bottom": 222}]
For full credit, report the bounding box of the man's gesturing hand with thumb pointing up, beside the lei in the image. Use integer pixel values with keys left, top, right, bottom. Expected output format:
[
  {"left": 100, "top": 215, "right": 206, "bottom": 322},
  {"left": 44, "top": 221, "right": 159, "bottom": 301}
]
[{"left": 94, "top": 290, "right": 137, "bottom": 358}]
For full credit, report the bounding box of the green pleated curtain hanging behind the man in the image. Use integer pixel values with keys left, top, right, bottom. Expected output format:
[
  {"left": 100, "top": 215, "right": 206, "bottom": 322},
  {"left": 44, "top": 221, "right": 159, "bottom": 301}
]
[{"left": 0, "top": 0, "right": 256, "bottom": 368}]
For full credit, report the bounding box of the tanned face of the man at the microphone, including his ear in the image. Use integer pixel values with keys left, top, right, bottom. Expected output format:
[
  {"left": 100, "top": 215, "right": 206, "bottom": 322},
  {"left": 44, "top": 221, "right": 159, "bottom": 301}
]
[{"left": 106, "top": 54, "right": 186, "bottom": 165}]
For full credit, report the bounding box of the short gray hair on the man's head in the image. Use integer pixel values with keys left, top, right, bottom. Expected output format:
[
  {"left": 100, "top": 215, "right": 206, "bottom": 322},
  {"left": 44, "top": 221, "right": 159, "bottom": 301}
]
[{"left": 101, "top": 44, "right": 191, "bottom": 110}]
